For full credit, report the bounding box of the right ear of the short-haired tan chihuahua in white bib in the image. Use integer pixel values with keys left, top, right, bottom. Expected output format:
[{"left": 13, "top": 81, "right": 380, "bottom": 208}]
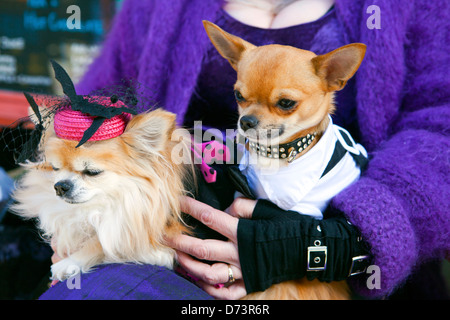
[{"left": 311, "top": 43, "right": 366, "bottom": 92}]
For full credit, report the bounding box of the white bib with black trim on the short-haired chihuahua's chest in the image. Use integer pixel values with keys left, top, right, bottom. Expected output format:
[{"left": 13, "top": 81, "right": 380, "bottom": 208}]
[{"left": 239, "top": 117, "right": 367, "bottom": 219}]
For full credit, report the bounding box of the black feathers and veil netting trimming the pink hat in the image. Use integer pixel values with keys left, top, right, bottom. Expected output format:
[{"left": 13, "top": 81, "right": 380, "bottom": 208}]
[{"left": 0, "top": 61, "right": 162, "bottom": 166}]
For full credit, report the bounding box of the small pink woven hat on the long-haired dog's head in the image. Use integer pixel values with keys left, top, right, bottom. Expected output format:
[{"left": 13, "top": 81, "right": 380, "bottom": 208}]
[{"left": 54, "top": 97, "right": 131, "bottom": 141}]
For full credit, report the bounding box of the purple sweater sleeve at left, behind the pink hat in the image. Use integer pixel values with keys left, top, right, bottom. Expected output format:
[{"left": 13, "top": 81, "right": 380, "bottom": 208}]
[{"left": 76, "top": 0, "right": 153, "bottom": 94}]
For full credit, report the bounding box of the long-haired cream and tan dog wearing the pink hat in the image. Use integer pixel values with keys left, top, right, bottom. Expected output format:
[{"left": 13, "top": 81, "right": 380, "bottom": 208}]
[{"left": 13, "top": 109, "right": 189, "bottom": 281}]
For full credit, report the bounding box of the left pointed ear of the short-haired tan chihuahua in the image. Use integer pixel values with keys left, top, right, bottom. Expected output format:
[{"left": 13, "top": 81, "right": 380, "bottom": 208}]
[{"left": 203, "top": 20, "right": 256, "bottom": 70}]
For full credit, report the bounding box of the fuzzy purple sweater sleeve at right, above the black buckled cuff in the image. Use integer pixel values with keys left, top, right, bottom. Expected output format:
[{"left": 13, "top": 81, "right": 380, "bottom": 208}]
[{"left": 332, "top": 1, "right": 450, "bottom": 297}]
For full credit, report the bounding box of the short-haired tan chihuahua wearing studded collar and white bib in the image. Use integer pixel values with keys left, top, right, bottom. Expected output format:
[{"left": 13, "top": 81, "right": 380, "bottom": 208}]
[{"left": 203, "top": 21, "right": 367, "bottom": 299}]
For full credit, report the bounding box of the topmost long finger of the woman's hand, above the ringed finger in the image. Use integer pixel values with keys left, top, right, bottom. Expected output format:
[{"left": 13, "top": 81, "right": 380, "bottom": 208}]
[{"left": 181, "top": 196, "right": 239, "bottom": 242}]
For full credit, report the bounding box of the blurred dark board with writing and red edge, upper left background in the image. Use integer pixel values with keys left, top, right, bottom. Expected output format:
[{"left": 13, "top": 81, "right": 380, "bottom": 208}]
[{"left": 0, "top": 0, "right": 122, "bottom": 125}]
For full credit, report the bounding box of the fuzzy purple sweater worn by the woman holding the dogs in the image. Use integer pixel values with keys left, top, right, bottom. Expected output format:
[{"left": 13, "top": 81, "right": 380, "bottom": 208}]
[{"left": 78, "top": 0, "right": 450, "bottom": 297}]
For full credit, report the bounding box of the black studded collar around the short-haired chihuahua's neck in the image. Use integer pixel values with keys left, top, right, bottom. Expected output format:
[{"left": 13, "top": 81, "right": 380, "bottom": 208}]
[{"left": 249, "top": 132, "right": 317, "bottom": 163}]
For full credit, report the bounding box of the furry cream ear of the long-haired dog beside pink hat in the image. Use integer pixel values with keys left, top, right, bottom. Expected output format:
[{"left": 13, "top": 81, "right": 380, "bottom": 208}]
[{"left": 122, "top": 109, "right": 176, "bottom": 154}]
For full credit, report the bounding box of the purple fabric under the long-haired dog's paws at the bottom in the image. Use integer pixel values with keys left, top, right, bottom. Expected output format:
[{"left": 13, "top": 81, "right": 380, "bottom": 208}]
[{"left": 39, "top": 264, "right": 212, "bottom": 300}]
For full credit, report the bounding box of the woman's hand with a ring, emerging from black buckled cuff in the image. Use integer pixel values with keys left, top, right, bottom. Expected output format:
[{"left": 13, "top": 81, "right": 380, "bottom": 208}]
[{"left": 168, "top": 197, "right": 256, "bottom": 300}]
